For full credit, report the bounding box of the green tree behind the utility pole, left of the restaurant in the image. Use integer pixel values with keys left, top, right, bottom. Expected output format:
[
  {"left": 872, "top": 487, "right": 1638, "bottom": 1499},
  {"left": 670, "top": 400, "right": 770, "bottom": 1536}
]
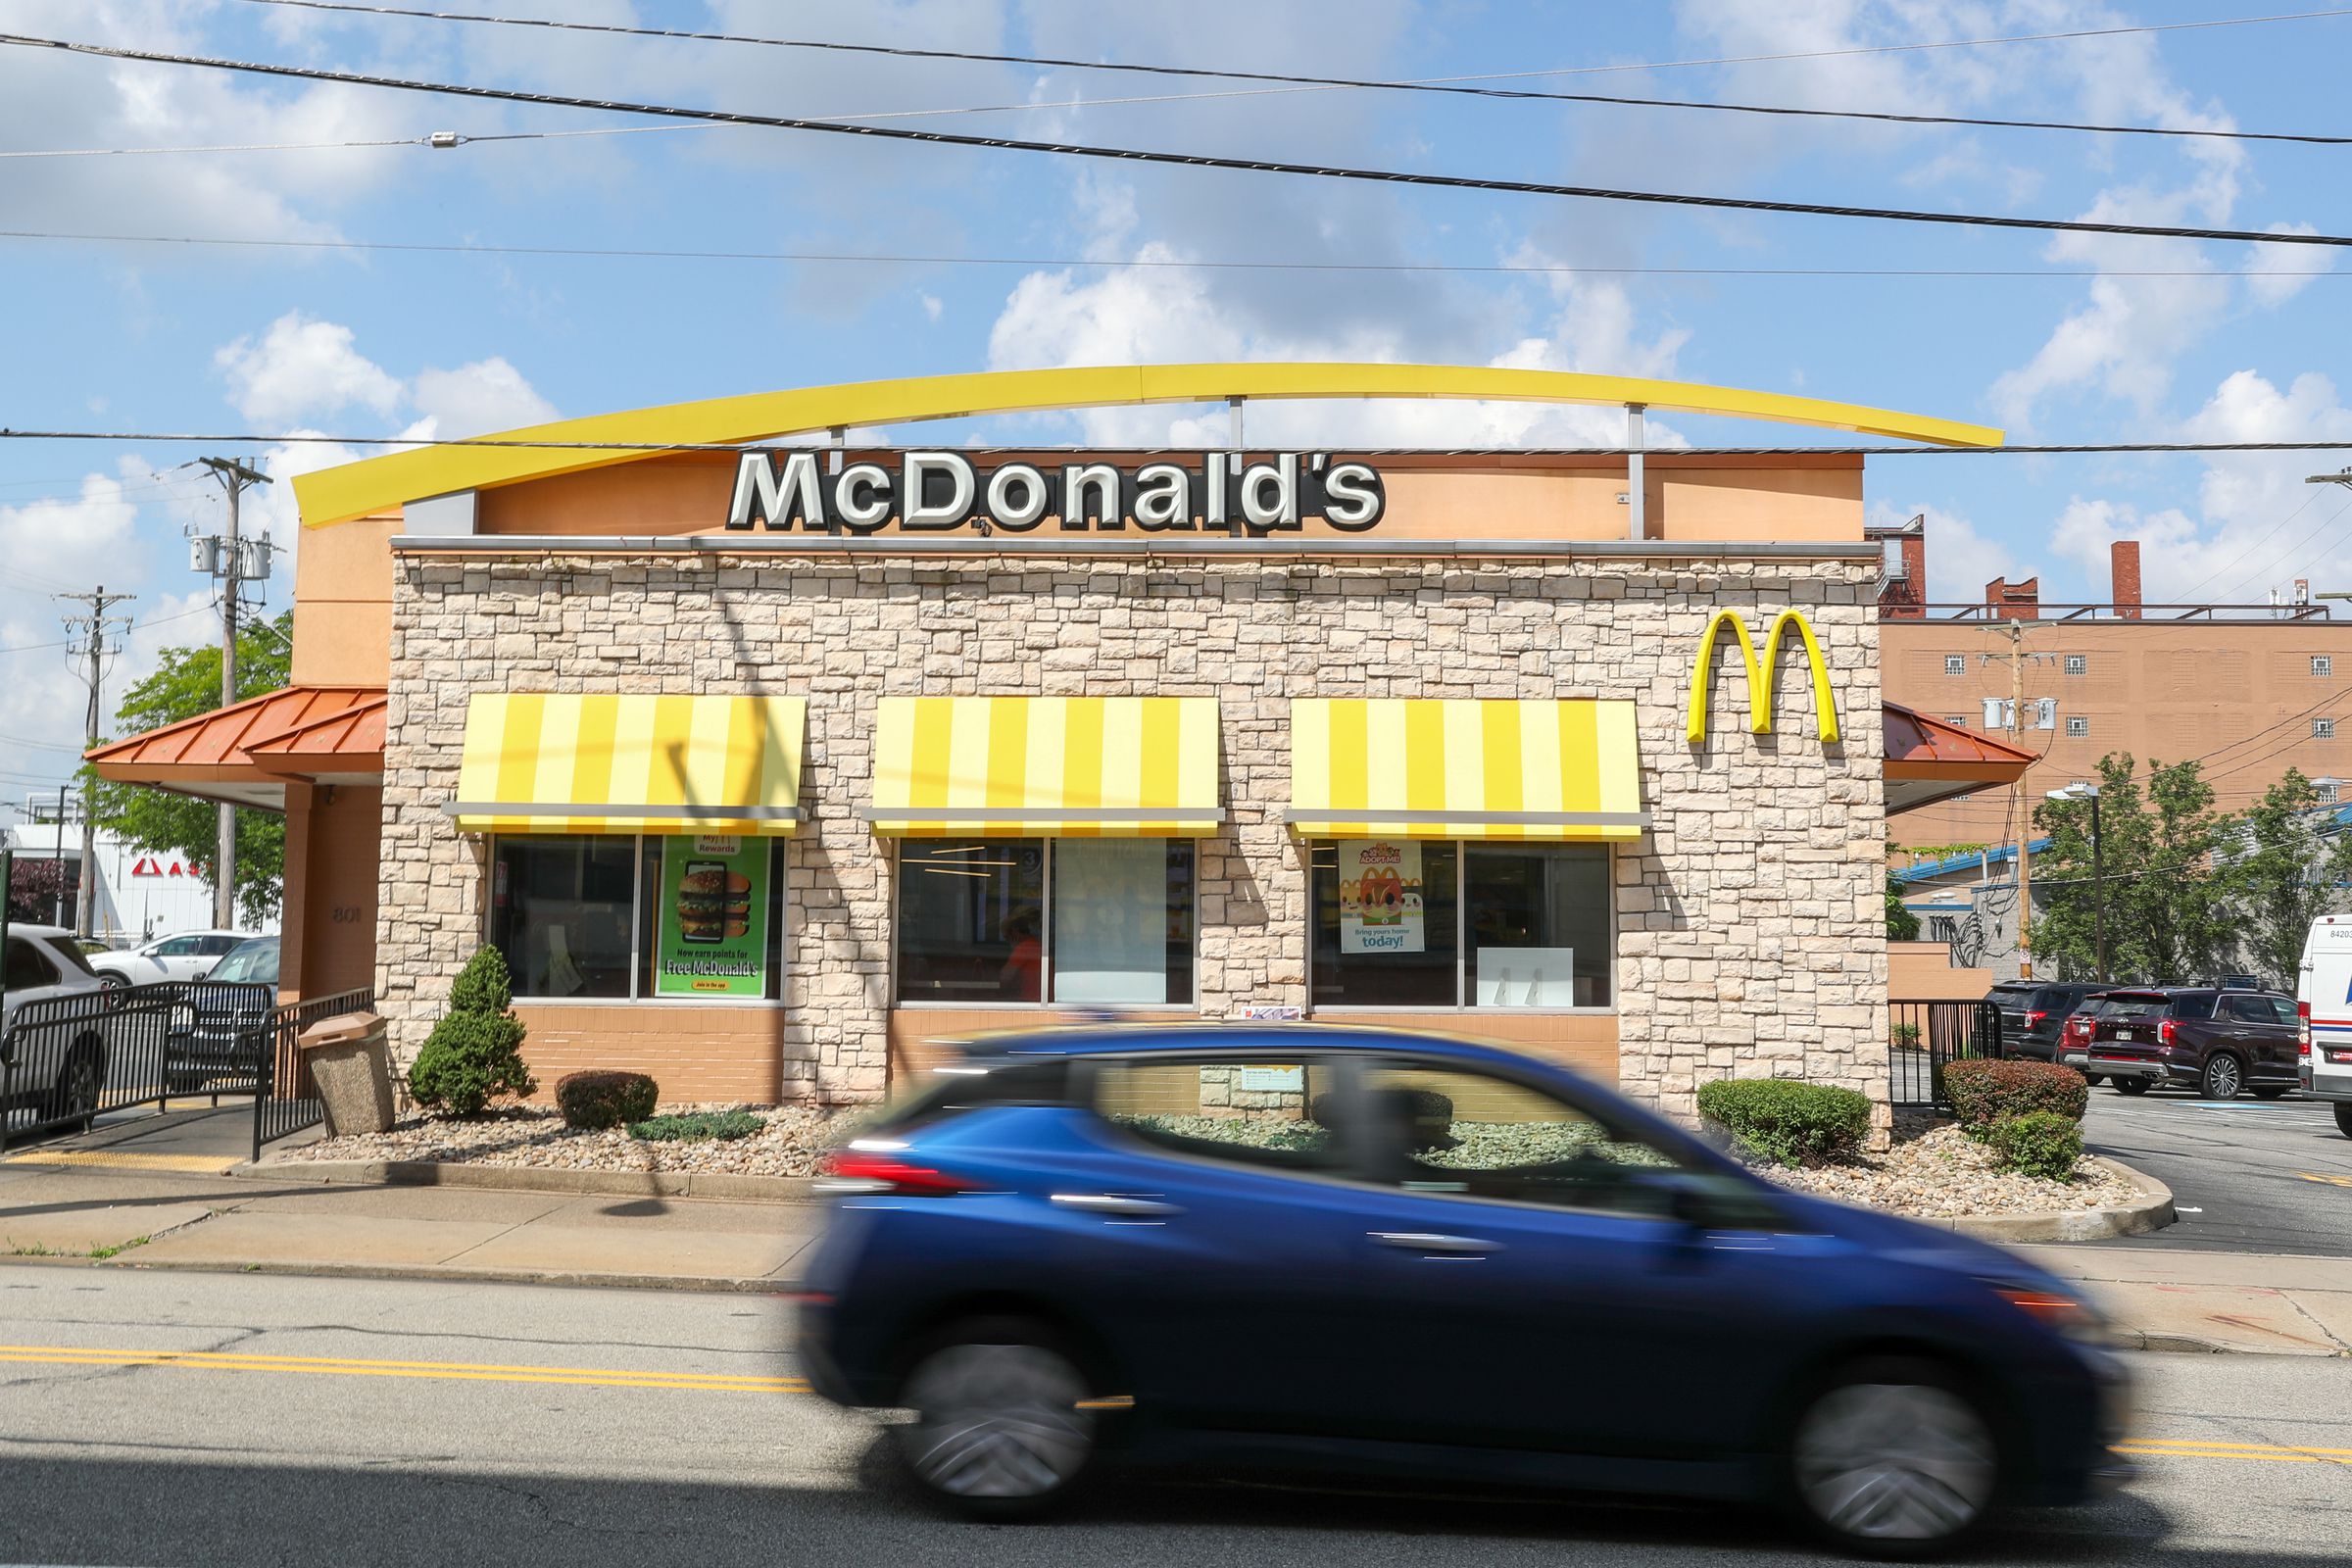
[{"left": 92, "top": 612, "right": 294, "bottom": 924}]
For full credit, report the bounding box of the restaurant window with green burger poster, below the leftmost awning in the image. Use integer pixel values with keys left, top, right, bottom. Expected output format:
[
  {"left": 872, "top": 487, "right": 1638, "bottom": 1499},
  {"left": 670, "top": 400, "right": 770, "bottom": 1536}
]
[{"left": 489, "top": 835, "right": 783, "bottom": 1002}]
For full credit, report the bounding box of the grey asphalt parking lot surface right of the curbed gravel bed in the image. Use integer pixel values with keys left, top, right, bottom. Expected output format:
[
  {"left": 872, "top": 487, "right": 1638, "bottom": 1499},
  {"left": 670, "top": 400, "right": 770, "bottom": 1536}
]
[{"left": 2083, "top": 1086, "right": 2352, "bottom": 1257}]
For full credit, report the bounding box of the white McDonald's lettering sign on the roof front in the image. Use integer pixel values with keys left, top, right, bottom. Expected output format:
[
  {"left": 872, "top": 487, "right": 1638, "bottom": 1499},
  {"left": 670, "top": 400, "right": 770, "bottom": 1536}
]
[{"left": 727, "top": 449, "right": 1388, "bottom": 534}]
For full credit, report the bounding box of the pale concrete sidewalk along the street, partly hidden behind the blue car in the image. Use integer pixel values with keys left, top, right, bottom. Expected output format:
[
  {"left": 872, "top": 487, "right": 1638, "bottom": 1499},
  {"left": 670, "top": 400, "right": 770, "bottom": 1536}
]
[{"left": 0, "top": 1112, "right": 2352, "bottom": 1356}]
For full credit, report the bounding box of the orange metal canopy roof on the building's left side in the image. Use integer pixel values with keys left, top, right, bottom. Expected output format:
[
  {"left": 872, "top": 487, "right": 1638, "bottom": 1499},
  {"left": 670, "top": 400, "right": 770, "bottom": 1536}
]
[{"left": 87, "top": 686, "right": 386, "bottom": 811}]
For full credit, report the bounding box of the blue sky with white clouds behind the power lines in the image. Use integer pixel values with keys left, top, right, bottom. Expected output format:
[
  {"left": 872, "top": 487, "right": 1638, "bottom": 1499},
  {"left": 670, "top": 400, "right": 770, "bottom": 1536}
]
[{"left": 0, "top": 0, "right": 2352, "bottom": 800}]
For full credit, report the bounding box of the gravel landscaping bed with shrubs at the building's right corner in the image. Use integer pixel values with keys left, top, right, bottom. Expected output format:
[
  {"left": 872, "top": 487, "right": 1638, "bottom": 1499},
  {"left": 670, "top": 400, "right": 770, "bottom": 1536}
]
[{"left": 1757, "top": 1114, "right": 2142, "bottom": 1220}]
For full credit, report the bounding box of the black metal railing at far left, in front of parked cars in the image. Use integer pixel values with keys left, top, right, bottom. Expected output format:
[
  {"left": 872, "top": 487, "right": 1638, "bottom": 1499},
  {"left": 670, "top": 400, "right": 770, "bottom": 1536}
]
[{"left": 0, "top": 980, "right": 272, "bottom": 1150}]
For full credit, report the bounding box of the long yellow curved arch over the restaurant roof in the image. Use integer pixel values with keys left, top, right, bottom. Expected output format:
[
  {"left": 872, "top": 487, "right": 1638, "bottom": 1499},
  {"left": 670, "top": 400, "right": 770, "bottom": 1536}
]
[{"left": 294, "top": 365, "right": 2001, "bottom": 526}]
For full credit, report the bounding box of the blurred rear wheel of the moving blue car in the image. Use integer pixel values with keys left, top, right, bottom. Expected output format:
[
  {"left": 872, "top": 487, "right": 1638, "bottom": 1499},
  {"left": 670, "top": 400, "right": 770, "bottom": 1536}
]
[{"left": 899, "top": 1321, "right": 1096, "bottom": 1519}]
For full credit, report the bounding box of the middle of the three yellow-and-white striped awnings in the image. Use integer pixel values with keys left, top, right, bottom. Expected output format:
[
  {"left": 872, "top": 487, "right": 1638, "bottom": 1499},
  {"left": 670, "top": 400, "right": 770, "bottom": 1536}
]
[{"left": 863, "top": 696, "right": 1223, "bottom": 839}]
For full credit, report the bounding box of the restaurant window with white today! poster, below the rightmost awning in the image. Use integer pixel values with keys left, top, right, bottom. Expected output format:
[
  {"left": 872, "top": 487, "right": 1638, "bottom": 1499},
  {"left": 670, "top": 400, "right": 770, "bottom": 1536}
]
[{"left": 1307, "top": 839, "right": 1616, "bottom": 1008}]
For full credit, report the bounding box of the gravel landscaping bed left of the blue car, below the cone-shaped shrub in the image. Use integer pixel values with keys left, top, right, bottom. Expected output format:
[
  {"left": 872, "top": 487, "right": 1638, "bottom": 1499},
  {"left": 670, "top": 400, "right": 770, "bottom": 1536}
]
[{"left": 264, "top": 1104, "right": 863, "bottom": 1175}]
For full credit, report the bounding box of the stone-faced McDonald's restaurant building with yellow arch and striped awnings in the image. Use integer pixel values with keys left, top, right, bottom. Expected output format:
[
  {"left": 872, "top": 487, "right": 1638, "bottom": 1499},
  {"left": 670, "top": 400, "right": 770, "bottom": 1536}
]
[{"left": 94, "top": 367, "right": 2032, "bottom": 1114}]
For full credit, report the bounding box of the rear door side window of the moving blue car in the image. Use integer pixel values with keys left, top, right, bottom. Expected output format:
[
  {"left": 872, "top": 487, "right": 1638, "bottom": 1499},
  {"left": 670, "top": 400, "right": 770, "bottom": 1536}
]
[{"left": 1094, "top": 1051, "right": 1343, "bottom": 1171}]
